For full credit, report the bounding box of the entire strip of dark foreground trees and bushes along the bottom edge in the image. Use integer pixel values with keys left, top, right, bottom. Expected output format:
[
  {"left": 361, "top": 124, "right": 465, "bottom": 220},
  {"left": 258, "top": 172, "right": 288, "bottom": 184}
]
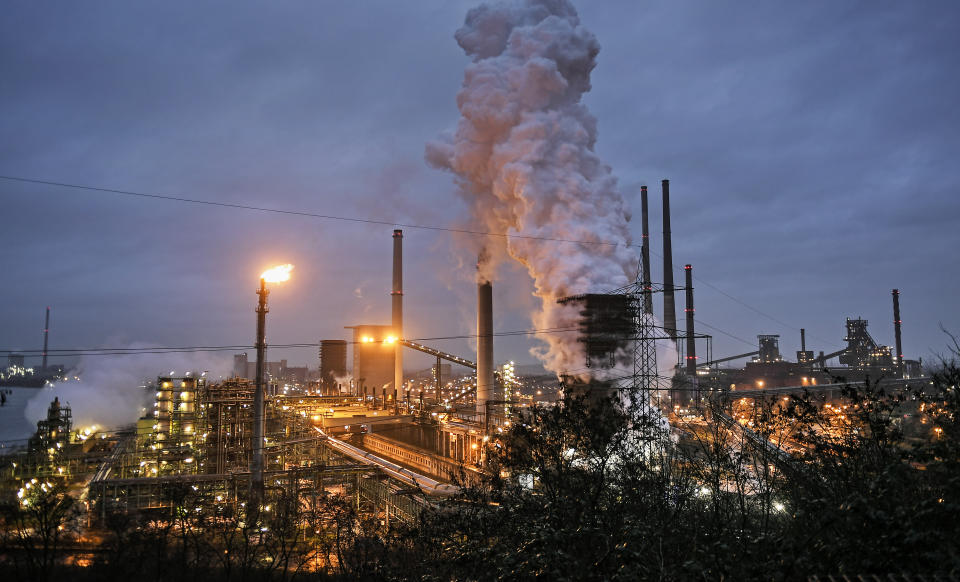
[{"left": 0, "top": 361, "right": 960, "bottom": 582}]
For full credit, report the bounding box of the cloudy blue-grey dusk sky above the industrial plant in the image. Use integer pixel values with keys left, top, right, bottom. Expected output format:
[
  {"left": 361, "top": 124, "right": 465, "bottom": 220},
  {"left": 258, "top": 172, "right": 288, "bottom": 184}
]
[{"left": 0, "top": 0, "right": 960, "bottom": 372}]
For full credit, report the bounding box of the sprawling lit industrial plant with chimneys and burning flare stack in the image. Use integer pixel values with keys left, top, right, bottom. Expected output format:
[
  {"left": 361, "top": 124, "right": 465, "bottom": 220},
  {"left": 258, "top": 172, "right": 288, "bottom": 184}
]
[{"left": 0, "top": 180, "right": 925, "bottom": 556}]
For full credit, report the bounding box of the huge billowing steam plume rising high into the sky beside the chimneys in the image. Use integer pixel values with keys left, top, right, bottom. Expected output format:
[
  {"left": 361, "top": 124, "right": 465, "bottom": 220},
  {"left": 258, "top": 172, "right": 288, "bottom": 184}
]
[{"left": 426, "top": 0, "right": 637, "bottom": 373}]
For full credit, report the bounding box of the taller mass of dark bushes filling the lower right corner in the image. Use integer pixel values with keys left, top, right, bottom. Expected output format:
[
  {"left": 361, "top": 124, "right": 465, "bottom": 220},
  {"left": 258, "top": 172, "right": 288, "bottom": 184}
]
[{"left": 390, "top": 362, "right": 960, "bottom": 580}]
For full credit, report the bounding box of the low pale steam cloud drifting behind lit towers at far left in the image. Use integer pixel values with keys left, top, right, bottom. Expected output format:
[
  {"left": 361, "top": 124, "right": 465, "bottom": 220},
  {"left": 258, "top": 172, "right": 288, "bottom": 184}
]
[{"left": 24, "top": 346, "right": 232, "bottom": 436}]
